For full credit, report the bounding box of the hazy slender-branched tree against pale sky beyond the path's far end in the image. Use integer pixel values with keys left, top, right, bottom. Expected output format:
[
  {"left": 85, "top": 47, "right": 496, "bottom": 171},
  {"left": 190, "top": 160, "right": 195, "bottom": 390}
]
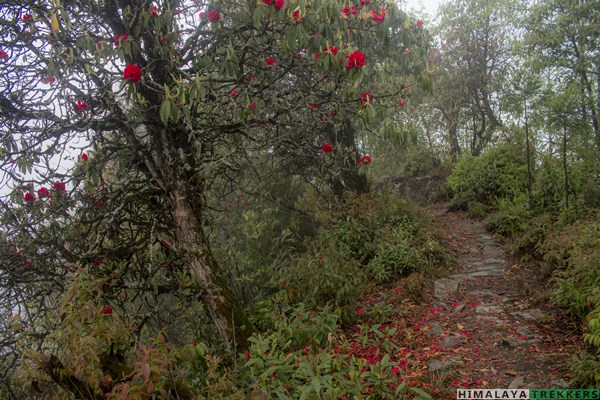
[{"left": 424, "top": 0, "right": 520, "bottom": 158}]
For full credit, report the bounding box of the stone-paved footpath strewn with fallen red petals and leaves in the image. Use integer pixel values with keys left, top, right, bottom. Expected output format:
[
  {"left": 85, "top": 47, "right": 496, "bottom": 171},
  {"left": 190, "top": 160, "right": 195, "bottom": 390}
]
[{"left": 428, "top": 209, "right": 578, "bottom": 388}]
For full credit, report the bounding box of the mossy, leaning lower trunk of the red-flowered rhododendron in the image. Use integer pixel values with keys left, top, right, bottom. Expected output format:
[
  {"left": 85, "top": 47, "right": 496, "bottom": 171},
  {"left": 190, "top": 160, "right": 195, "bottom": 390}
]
[{"left": 170, "top": 190, "right": 253, "bottom": 354}]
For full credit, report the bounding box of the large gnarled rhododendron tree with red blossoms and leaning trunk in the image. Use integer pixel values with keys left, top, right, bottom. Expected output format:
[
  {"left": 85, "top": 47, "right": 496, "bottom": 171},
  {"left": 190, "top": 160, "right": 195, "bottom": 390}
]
[{"left": 0, "top": 0, "right": 427, "bottom": 396}]
